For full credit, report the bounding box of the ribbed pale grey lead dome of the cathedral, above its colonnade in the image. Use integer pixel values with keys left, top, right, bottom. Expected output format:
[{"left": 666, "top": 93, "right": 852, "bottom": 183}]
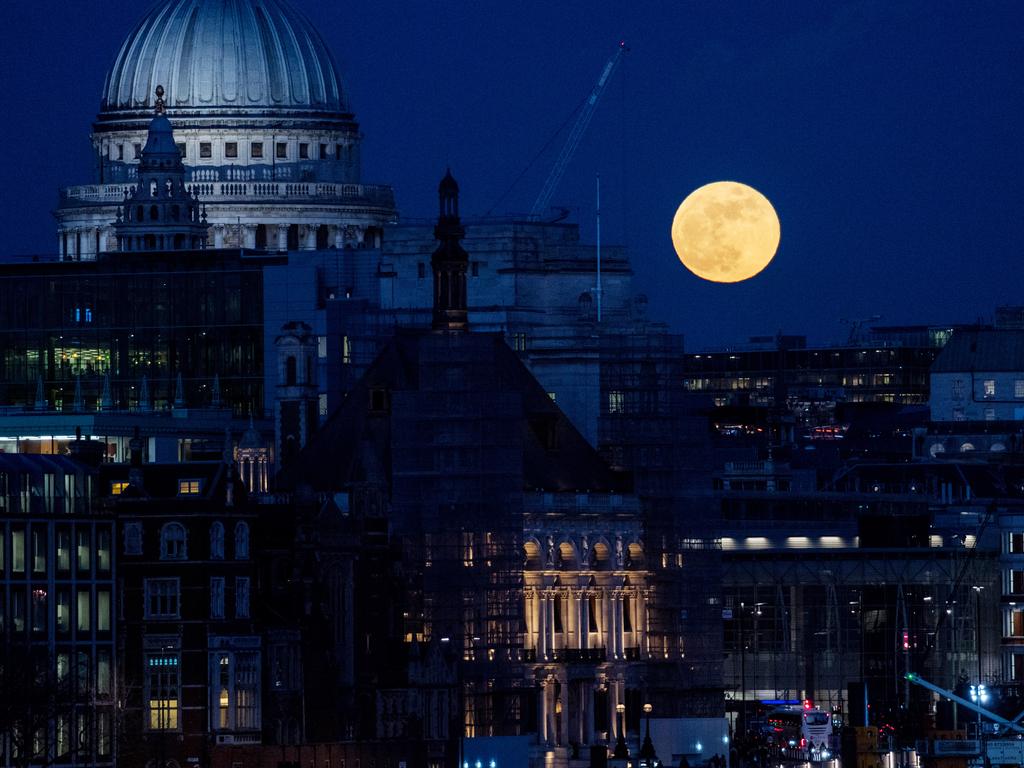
[{"left": 99, "top": 0, "right": 349, "bottom": 121}]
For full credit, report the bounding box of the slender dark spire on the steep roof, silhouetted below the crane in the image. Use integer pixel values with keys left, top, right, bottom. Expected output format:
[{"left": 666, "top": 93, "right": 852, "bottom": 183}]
[{"left": 430, "top": 168, "right": 469, "bottom": 331}]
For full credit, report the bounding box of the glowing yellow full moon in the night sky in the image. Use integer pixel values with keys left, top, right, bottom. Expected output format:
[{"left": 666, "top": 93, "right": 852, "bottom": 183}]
[{"left": 672, "top": 181, "right": 780, "bottom": 283}]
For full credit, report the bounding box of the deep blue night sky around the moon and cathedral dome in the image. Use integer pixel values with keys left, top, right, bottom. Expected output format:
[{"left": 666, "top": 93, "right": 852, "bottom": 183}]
[{"left": 0, "top": 0, "right": 1024, "bottom": 349}]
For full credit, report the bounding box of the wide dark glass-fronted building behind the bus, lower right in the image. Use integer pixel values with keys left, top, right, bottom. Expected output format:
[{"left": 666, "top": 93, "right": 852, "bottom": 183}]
[{"left": 721, "top": 462, "right": 1012, "bottom": 727}]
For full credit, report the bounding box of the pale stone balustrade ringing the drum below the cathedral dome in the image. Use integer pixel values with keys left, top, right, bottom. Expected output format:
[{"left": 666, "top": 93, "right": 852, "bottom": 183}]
[{"left": 60, "top": 181, "right": 394, "bottom": 208}]
